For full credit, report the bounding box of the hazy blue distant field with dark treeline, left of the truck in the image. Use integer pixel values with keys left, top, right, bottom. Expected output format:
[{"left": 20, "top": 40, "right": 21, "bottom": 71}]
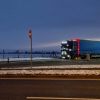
[{"left": 0, "top": 49, "right": 60, "bottom": 59}]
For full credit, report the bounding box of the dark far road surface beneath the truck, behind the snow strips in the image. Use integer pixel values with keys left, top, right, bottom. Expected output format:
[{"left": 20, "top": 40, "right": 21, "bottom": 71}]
[{"left": 0, "top": 59, "right": 100, "bottom": 69}]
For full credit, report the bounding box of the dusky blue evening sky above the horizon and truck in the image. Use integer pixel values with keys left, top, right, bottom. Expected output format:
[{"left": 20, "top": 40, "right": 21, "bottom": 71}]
[{"left": 0, "top": 0, "right": 100, "bottom": 50}]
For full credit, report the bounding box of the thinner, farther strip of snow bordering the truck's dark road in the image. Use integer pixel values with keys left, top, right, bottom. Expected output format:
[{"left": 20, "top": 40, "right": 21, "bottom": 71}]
[{"left": 0, "top": 65, "right": 100, "bottom": 70}]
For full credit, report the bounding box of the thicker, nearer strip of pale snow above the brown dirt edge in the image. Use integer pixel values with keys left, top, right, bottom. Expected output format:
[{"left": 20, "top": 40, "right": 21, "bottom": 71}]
[{"left": 0, "top": 70, "right": 100, "bottom": 75}]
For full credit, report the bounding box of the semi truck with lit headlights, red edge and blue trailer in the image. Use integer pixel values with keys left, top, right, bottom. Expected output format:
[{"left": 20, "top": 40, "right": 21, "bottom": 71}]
[{"left": 61, "top": 38, "right": 100, "bottom": 59}]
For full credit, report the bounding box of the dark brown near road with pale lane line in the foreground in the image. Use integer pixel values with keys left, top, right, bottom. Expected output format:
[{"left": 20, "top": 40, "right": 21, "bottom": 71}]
[{"left": 0, "top": 79, "right": 100, "bottom": 100}]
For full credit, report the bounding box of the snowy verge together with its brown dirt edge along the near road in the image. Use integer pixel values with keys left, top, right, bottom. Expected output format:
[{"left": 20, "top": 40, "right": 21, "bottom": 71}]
[{"left": 0, "top": 66, "right": 100, "bottom": 79}]
